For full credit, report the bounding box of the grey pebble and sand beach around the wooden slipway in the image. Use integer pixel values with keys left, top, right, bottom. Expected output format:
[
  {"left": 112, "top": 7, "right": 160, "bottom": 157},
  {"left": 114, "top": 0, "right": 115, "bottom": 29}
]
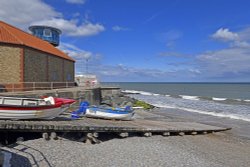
[{"left": 2, "top": 109, "right": 250, "bottom": 167}]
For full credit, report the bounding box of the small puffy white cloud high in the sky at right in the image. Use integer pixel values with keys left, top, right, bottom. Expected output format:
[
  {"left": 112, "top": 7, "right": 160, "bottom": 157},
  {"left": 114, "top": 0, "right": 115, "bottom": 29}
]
[{"left": 212, "top": 28, "right": 239, "bottom": 41}]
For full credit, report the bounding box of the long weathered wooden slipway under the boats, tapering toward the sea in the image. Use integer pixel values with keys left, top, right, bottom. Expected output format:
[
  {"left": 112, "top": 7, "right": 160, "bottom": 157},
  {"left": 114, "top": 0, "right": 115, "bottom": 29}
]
[{"left": 0, "top": 117, "right": 230, "bottom": 135}]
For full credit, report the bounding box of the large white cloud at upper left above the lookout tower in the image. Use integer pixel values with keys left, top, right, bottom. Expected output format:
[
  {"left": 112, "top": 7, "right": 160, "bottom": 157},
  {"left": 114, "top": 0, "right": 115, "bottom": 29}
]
[{"left": 0, "top": 0, "right": 105, "bottom": 36}]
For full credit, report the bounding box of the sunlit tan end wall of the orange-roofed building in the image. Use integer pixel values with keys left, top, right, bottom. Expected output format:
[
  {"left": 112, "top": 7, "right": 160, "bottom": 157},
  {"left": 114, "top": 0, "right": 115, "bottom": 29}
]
[{"left": 0, "top": 44, "right": 21, "bottom": 83}]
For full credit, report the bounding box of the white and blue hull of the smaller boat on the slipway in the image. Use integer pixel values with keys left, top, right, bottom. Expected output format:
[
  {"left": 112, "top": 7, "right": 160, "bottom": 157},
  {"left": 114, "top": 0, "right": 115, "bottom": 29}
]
[{"left": 85, "top": 108, "right": 134, "bottom": 120}]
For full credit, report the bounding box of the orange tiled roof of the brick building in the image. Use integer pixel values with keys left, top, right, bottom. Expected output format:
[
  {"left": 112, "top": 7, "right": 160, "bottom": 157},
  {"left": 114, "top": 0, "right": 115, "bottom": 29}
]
[{"left": 0, "top": 21, "right": 75, "bottom": 61}]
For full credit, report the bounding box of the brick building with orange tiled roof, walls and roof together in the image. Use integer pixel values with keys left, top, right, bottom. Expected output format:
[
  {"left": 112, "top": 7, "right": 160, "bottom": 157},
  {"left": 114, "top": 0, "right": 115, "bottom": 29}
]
[{"left": 0, "top": 21, "right": 75, "bottom": 89}]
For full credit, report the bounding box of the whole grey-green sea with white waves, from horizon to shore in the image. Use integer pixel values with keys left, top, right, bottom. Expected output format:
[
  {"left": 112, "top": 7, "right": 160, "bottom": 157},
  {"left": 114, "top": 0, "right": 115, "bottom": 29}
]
[{"left": 103, "top": 82, "right": 250, "bottom": 122}]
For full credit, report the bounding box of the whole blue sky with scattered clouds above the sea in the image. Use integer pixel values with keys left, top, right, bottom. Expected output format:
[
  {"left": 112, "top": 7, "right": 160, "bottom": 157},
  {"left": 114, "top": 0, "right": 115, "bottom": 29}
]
[{"left": 0, "top": 0, "right": 250, "bottom": 82}]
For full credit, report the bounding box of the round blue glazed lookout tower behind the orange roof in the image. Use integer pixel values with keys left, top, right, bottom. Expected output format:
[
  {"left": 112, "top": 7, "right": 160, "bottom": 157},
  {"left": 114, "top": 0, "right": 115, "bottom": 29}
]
[{"left": 29, "top": 26, "right": 62, "bottom": 46}]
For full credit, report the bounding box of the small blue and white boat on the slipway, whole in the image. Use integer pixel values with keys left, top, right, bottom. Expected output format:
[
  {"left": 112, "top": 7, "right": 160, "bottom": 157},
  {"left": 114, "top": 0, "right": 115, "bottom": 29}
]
[{"left": 85, "top": 106, "right": 135, "bottom": 120}]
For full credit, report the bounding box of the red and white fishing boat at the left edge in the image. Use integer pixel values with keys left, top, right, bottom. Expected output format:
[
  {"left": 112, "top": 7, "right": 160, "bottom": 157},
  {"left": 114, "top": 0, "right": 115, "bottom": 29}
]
[{"left": 0, "top": 96, "right": 75, "bottom": 120}]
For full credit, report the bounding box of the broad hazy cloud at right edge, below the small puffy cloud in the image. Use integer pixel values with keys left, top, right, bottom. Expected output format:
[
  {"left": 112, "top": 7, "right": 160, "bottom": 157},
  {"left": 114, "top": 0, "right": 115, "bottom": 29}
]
[{"left": 197, "top": 48, "right": 250, "bottom": 79}]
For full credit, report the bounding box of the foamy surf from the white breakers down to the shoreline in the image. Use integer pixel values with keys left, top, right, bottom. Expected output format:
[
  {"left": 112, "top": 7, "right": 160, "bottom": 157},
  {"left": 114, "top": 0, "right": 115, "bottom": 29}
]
[{"left": 123, "top": 90, "right": 250, "bottom": 122}]
